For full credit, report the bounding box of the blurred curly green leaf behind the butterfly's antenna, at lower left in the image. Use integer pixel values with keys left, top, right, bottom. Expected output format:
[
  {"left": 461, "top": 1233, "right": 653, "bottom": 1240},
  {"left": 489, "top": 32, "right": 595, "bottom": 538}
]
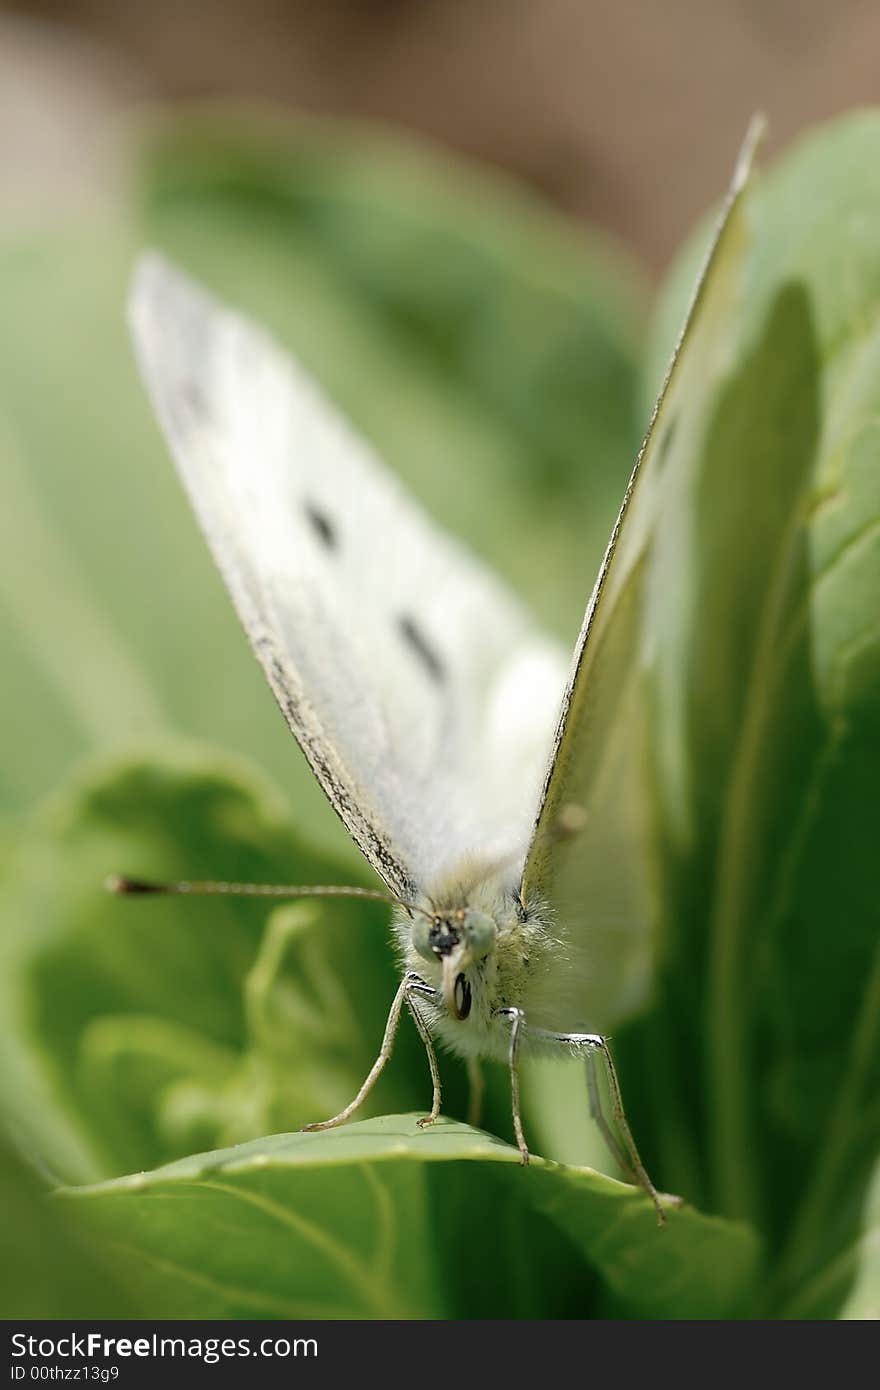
[{"left": 0, "top": 746, "right": 517, "bottom": 1182}]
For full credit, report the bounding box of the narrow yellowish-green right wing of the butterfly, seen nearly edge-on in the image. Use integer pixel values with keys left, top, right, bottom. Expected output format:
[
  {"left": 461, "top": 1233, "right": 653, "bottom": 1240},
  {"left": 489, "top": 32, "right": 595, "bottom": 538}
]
[{"left": 521, "top": 122, "right": 760, "bottom": 1029}]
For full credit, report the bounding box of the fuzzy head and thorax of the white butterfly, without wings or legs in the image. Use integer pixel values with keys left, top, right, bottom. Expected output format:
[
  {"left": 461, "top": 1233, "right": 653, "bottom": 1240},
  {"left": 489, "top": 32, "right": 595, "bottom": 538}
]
[{"left": 395, "top": 866, "right": 553, "bottom": 1058}]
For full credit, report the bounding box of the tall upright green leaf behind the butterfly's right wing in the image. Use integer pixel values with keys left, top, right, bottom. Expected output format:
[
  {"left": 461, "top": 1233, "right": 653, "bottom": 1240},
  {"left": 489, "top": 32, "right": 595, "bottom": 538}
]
[{"left": 620, "top": 114, "right": 880, "bottom": 1314}]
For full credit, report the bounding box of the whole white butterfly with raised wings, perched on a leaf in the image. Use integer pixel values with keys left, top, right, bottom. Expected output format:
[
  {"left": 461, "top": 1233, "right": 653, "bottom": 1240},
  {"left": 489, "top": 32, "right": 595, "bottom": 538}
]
[{"left": 115, "top": 129, "right": 758, "bottom": 1219}]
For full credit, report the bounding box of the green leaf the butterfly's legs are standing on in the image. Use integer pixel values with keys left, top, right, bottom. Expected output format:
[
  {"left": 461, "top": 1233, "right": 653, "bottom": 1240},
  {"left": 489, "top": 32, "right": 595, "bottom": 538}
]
[{"left": 60, "top": 1115, "right": 756, "bottom": 1318}]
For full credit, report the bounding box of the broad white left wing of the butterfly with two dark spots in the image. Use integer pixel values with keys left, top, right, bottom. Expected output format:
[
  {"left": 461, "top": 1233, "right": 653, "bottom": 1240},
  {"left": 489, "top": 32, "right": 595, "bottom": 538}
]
[{"left": 131, "top": 254, "right": 564, "bottom": 898}]
